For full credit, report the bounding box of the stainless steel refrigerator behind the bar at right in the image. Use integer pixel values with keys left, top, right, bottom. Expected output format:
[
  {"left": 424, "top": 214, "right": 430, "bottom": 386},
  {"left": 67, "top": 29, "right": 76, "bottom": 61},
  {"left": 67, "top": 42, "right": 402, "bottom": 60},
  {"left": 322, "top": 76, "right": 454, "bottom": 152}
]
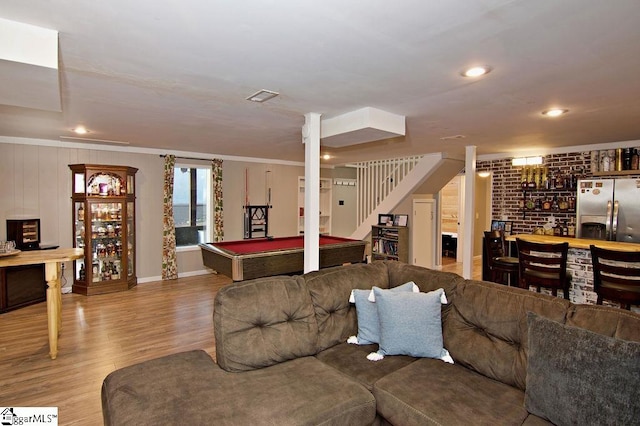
[{"left": 576, "top": 179, "right": 640, "bottom": 243}]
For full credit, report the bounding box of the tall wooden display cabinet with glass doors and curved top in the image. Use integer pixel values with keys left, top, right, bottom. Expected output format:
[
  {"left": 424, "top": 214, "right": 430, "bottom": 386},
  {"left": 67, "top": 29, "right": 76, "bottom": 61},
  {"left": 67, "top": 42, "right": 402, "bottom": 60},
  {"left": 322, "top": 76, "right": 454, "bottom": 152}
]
[{"left": 69, "top": 164, "right": 138, "bottom": 295}]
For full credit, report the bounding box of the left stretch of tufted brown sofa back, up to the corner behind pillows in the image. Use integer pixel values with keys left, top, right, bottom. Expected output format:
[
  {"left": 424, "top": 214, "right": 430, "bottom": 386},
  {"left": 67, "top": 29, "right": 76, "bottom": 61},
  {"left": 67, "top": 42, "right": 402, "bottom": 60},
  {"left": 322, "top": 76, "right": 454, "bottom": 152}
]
[{"left": 213, "top": 263, "right": 389, "bottom": 371}]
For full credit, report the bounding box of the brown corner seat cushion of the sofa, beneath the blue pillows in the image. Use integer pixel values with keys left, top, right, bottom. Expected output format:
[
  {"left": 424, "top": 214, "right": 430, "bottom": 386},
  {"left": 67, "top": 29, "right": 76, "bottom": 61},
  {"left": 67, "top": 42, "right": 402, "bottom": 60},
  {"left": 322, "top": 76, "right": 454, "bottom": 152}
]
[{"left": 316, "top": 343, "right": 416, "bottom": 390}]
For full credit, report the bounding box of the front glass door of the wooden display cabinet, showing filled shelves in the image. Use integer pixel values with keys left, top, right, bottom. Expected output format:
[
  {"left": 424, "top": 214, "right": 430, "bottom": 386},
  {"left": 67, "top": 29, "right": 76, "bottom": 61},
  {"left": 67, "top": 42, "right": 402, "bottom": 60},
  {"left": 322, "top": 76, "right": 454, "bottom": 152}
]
[{"left": 90, "top": 202, "right": 123, "bottom": 282}]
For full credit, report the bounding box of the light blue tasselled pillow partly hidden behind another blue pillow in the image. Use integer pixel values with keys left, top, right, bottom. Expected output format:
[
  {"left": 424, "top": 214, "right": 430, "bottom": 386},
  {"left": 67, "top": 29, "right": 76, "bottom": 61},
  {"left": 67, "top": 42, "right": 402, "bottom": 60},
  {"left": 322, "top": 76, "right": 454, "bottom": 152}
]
[{"left": 348, "top": 281, "right": 419, "bottom": 345}]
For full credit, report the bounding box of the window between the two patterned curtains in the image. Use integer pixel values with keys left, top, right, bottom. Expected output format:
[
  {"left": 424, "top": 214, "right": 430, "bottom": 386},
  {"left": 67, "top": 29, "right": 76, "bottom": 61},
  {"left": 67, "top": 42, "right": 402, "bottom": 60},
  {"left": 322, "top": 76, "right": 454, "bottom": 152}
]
[{"left": 173, "top": 164, "right": 212, "bottom": 247}]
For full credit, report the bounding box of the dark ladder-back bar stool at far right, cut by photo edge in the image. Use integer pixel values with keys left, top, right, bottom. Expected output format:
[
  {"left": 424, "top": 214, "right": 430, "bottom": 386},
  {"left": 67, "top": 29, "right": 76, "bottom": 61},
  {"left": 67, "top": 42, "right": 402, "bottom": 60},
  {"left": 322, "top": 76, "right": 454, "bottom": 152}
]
[{"left": 590, "top": 245, "right": 640, "bottom": 310}]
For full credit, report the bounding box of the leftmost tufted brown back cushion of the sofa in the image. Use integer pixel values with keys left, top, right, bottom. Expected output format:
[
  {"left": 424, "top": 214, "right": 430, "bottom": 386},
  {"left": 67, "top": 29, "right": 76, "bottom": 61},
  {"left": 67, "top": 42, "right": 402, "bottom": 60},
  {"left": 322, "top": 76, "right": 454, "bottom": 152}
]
[{"left": 213, "top": 277, "right": 318, "bottom": 371}]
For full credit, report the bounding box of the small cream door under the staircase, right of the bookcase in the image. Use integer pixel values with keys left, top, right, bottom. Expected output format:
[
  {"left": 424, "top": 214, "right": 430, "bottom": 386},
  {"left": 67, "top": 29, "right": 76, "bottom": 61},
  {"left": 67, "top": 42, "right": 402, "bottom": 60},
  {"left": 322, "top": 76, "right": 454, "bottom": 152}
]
[{"left": 409, "top": 199, "right": 436, "bottom": 268}]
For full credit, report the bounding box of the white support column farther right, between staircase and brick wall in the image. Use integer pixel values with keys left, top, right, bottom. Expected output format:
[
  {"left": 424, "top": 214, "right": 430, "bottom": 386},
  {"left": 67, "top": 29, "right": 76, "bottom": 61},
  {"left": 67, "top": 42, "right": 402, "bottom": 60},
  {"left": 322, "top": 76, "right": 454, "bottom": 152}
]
[{"left": 462, "top": 145, "right": 476, "bottom": 280}]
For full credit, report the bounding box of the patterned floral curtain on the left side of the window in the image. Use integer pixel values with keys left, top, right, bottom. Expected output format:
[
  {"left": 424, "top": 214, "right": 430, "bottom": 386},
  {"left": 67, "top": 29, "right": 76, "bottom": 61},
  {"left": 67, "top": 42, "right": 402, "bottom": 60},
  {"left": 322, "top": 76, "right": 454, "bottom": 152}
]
[{"left": 162, "top": 155, "right": 178, "bottom": 280}]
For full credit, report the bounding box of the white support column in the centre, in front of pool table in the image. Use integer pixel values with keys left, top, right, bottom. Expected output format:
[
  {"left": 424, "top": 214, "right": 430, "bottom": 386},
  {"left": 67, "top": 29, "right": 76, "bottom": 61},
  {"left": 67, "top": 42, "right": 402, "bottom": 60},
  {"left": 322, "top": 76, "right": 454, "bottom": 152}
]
[{"left": 302, "top": 112, "right": 320, "bottom": 273}]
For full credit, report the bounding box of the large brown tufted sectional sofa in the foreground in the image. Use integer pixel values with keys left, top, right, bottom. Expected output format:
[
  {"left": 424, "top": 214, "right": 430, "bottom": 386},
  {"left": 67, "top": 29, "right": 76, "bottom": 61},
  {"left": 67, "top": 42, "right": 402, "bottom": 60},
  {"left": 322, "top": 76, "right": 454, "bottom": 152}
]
[{"left": 102, "top": 262, "right": 640, "bottom": 425}]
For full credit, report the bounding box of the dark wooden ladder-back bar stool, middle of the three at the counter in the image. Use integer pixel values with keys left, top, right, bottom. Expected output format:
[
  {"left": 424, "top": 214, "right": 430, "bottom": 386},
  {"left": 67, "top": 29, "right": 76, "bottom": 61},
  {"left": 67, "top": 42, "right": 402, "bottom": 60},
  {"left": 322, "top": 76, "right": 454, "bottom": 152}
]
[{"left": 516, "top": 238, "right": 571, "bottom": 300}]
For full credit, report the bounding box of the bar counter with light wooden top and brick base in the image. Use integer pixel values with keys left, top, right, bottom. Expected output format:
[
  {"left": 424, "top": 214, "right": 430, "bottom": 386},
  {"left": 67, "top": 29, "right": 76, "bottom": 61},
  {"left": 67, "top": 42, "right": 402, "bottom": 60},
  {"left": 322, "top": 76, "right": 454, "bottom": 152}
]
[{"left": 505, "top": 234, "right": 640, "bottom": 313}]
